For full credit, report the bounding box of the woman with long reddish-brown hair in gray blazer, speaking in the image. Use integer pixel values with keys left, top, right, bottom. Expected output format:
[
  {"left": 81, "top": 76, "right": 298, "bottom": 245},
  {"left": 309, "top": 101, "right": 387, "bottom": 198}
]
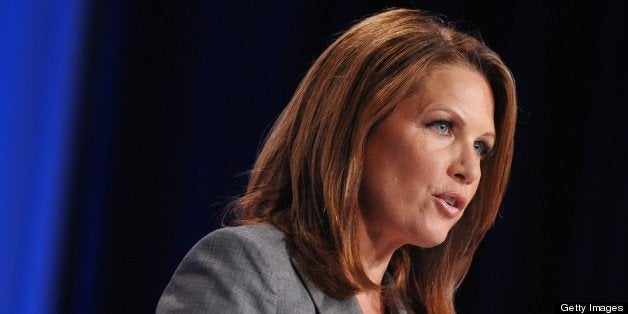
[{"left": 157, "top": 9, "right": 516, "bottom": 313}]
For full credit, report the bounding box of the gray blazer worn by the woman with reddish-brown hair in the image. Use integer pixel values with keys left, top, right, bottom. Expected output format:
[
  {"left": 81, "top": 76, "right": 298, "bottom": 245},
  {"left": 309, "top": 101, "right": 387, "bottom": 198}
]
[{"left": 157, "top": 225, "right": 405, "bottom": 313}]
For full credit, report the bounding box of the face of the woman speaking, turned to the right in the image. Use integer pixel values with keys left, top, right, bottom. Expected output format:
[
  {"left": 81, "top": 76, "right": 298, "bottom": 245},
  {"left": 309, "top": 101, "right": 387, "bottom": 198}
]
[{"left": 360, "top": 65, "right": 495, "bottom": 249}]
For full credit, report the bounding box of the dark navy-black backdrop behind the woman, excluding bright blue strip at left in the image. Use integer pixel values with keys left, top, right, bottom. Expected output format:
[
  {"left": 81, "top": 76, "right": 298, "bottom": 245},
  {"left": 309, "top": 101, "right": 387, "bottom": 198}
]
[{"left": 57, "top": 1, "right": 628, "bottom": 313}]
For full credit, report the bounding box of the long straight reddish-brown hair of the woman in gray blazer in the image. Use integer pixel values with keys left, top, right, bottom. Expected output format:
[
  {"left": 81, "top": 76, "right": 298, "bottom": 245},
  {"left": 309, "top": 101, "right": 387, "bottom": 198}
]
[{"left": 233, "top": 9, "right": 516, "bottom": 313}]
